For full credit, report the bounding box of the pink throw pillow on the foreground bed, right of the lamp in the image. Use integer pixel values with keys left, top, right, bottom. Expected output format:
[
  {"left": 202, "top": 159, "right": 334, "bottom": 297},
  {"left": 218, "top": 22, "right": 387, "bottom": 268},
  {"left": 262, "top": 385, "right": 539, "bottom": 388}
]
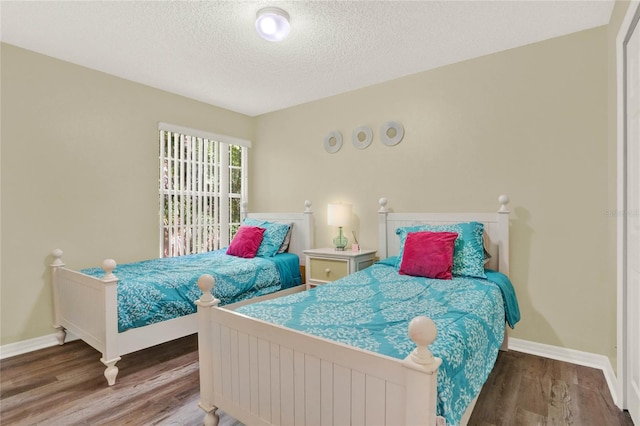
[{"left": 398, "top": 231, "right": 458, "bottom": 280}]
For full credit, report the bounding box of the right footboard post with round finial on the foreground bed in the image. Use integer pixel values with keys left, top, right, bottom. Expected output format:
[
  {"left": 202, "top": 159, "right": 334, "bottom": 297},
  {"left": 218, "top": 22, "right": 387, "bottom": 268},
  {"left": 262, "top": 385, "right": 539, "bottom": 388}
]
[{"left": 402, "top": 316, "right": 442, "bottom": 426}]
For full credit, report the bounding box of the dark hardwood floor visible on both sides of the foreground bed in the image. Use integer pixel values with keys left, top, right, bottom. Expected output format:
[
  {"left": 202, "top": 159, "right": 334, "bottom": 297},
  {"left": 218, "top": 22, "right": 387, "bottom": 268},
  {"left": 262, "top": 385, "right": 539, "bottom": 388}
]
[{"left": 0, "top": 336, "right": 633, "bottom": 426}]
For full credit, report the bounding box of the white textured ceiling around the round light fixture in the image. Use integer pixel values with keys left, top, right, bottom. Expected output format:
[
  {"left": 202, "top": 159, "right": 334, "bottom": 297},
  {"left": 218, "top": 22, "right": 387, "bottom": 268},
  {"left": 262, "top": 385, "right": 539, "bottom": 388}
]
[{"left": 0, "top": 0, "right": 614, "bottom": 116}]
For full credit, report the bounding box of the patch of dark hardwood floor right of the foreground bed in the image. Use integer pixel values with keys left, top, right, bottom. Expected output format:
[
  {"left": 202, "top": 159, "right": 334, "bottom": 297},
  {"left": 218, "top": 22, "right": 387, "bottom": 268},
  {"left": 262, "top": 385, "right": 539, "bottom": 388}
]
[{"left": 469, "top": 351, "right": 633, "bottom": 426}]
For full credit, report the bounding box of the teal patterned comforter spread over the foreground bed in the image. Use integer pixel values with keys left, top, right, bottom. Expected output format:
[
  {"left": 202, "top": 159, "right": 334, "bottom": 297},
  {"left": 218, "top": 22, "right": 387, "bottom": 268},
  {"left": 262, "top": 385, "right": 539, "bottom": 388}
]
[{"left": 238, "top": 262, "right": 520, "bottom": 425}]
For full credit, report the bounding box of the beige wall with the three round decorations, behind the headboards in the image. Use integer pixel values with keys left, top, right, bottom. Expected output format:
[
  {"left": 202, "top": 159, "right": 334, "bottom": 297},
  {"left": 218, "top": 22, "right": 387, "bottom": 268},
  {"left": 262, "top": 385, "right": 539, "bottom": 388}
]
[{"left": 250, "top": 27, "right": 616, "bottom": 358}]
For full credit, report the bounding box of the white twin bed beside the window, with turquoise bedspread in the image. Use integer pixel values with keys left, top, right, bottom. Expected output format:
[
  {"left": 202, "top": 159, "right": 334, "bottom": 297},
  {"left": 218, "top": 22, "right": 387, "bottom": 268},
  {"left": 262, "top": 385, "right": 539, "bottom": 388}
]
[{"left": 51, "top": 202, "right": 314, "bottom": 385}]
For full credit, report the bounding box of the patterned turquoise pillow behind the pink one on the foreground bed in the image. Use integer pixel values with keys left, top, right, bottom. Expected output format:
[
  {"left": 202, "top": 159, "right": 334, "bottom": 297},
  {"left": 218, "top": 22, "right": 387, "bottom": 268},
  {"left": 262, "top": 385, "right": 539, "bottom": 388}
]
[{"left": 396, "top": 222, "right": 487, "bottom": 278}]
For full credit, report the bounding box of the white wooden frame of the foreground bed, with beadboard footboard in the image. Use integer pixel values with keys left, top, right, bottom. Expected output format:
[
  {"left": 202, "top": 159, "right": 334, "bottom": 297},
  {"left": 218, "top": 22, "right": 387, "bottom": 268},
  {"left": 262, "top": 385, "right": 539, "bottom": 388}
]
[{"left": 196, "top": 195, "right": 509, "bottom": 426}]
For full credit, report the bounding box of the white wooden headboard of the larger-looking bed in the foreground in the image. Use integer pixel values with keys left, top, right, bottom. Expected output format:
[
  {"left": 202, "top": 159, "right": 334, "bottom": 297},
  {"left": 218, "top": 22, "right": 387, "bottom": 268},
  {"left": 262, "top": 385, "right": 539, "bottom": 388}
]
[{"left": 378, "top": 195, "right": 509, "bottom": 275}]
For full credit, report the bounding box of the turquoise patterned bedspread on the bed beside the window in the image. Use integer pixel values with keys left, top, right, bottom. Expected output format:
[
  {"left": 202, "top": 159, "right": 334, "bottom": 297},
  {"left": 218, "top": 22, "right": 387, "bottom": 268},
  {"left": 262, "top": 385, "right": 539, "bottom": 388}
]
[{"left": 80, "top": 249, "right": 302, "bottom": 332}]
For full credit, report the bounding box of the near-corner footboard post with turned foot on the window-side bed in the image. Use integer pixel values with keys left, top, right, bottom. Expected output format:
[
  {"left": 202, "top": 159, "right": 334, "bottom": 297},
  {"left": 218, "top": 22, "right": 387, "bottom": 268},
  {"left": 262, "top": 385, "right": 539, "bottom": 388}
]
[{"left": 100, "top": 259, "right": 122, "bottom": 386}]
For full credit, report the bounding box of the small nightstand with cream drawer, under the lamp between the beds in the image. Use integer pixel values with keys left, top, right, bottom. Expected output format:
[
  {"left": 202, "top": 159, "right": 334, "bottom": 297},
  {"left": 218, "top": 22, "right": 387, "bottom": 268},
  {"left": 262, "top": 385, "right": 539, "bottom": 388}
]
[{"left": 304, "top": 248, "right": 376, "bottom": 290}]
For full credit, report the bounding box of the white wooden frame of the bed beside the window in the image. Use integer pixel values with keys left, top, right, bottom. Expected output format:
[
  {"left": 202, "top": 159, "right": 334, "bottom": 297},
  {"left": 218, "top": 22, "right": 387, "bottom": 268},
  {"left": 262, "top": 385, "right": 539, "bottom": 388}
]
[{"left": 51, "top": 201, "right": 314, "bottom": 386}]
